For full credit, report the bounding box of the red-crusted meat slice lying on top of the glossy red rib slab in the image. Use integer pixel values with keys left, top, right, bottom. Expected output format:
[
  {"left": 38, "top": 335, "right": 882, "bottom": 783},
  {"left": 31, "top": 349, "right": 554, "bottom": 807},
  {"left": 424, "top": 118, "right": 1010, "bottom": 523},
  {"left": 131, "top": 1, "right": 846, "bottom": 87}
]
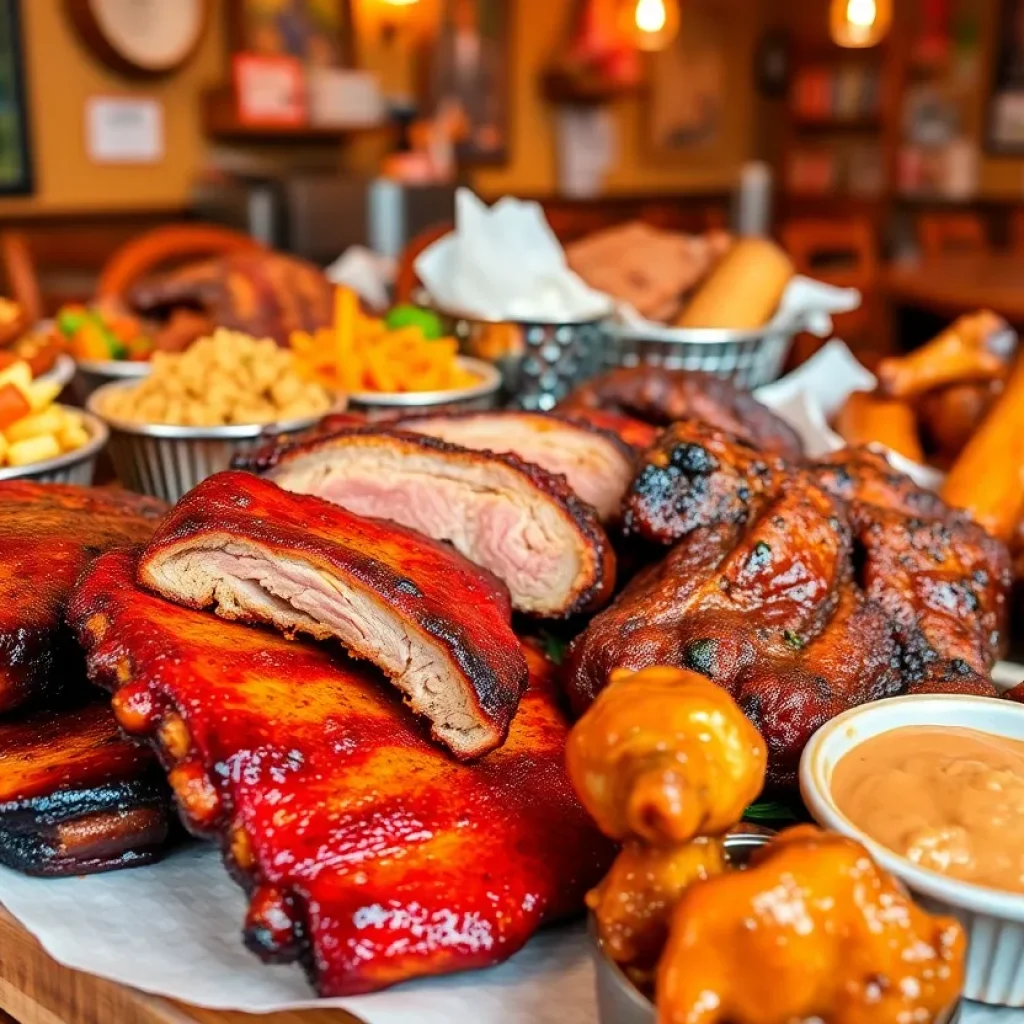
[{"left": 139, "top": 472, "right": 526, "bottom": 758}]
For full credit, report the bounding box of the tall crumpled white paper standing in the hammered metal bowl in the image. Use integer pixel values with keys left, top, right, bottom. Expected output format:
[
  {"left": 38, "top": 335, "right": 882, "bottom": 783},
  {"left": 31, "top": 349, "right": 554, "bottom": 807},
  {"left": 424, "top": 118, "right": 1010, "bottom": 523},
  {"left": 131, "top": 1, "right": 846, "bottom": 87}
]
[{"left": 416, "top": 188, "right": 611, "bottom": 324}]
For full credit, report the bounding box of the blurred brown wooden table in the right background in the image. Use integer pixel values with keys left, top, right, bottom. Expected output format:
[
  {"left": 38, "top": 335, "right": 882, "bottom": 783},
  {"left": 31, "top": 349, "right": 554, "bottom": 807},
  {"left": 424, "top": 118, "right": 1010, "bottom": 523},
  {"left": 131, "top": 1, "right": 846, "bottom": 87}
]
[{"left": 883, "top": 252, "right": 1024, "bottom": 325}]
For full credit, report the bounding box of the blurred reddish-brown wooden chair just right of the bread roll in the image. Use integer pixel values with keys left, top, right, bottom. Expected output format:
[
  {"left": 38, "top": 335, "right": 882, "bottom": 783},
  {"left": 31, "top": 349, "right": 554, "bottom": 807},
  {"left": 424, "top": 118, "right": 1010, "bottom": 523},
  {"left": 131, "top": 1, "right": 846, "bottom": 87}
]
[{"left": 780, "top": 217, "right": 889, "bottom": 366}]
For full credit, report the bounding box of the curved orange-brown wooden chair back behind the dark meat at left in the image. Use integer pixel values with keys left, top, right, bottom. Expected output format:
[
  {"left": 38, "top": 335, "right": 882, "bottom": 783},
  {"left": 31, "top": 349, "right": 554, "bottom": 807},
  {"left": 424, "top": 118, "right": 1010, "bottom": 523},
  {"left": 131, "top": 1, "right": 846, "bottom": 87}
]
[{"left": 96, "top": 224, "right": 264, "bottom": 299}]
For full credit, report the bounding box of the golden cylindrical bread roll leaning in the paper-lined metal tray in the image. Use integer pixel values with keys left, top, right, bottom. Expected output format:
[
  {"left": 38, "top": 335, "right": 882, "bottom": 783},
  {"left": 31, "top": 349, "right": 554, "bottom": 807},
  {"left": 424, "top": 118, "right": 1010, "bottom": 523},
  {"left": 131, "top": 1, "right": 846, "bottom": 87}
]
[{"left": 676, "top": 239, "right": 794, "bottom": 330}]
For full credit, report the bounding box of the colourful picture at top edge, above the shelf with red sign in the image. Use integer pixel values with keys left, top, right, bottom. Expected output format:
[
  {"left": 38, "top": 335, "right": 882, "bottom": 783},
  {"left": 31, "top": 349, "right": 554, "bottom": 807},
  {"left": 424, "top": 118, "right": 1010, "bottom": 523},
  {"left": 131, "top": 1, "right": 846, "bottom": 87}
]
[{"left": 229, "top": 0, "right": 355, "bottom": 68}]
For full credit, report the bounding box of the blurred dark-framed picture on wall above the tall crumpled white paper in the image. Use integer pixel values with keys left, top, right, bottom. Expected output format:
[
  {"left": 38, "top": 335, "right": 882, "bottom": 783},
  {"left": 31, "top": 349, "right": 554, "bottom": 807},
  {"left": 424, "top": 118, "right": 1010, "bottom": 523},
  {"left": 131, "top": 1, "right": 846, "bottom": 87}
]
[{"left": 424, "top": 0, "right": 511, "bottom": 164}]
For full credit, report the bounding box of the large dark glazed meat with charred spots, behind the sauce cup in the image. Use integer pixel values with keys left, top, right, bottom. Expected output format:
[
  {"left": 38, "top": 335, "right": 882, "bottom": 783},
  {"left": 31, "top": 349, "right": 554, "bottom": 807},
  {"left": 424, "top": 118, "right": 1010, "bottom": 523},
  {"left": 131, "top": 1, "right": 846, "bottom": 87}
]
[{"left": 566, "top": 421, "right": 1010, "bottom": 784}]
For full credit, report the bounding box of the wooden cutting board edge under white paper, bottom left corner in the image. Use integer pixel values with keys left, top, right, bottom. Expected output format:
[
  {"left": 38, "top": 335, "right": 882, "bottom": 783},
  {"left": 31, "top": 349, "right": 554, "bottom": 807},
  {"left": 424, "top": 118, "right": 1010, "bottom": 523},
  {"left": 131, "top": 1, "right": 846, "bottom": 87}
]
[{"left": 0, "top": 908, "right": 359, "bottom": 1024}]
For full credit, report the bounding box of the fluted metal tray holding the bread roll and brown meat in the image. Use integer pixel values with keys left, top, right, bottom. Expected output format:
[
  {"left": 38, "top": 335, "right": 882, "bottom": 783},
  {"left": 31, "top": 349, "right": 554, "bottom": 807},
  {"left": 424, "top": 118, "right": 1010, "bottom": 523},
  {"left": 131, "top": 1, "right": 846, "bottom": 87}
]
[{"left": 602, "top": 325, "right": 799, "bottom": 389}]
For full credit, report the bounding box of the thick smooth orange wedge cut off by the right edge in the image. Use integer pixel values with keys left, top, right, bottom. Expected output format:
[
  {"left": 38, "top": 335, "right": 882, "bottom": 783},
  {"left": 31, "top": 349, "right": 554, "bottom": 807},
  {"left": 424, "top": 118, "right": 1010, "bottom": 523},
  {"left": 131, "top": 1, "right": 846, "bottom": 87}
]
[{"left": 942, "top": 360, "right": 1024, "bottom": 541}]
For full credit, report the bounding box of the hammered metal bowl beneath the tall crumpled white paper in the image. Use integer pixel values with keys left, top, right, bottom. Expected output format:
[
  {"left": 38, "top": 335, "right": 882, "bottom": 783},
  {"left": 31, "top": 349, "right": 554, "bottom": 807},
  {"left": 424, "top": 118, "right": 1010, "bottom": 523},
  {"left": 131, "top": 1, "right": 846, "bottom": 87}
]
[{"left": 437, "top": 310, "right": 608, "bottom": 412}]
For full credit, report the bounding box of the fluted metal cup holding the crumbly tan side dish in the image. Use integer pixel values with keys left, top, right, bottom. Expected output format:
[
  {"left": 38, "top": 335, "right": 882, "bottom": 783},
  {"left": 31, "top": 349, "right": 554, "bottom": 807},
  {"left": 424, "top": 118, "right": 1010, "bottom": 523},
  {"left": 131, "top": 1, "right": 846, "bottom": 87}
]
[{"left": 86, "top": 381, "right": 325, "bottom": 504}]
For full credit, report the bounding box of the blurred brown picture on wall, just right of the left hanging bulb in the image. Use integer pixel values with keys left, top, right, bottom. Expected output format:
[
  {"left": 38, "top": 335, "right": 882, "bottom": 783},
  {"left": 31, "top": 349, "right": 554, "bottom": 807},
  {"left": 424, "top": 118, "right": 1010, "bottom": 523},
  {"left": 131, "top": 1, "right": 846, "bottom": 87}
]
[{"left": 641, "top": 0, "right": 757, "bottom": 168}]
